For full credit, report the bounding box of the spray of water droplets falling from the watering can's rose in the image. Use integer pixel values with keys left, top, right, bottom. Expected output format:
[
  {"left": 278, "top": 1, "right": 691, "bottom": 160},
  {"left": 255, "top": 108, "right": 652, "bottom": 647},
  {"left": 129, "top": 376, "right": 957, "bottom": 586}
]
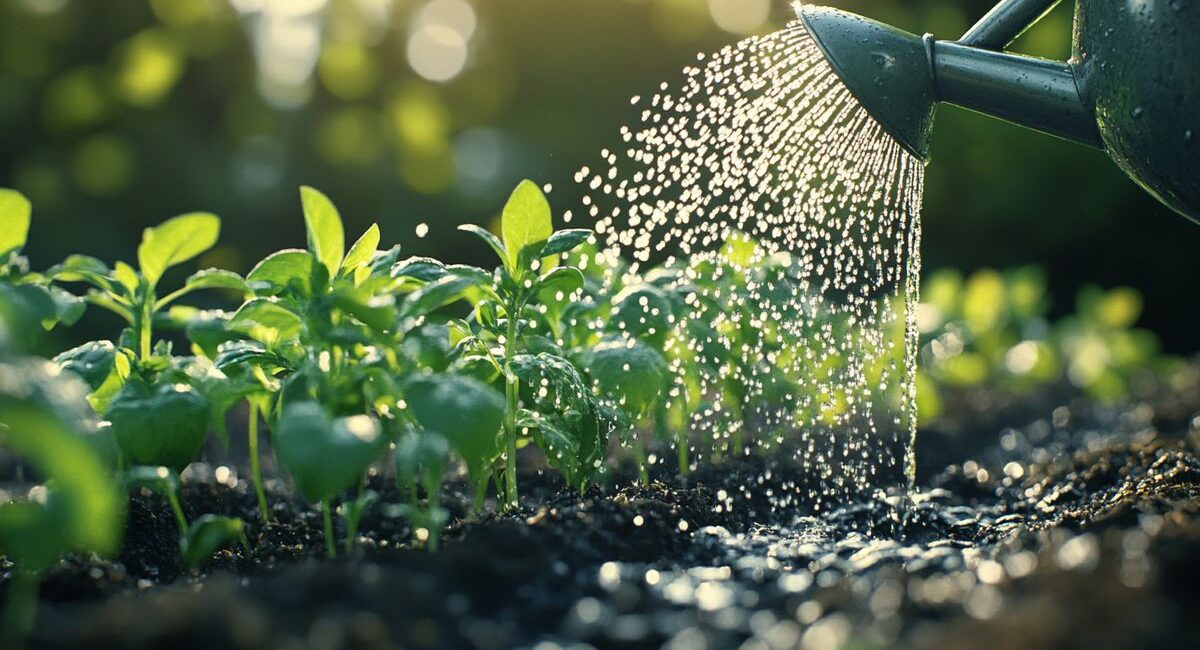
[{"left": 576, "top": 23, "right": 924, "bottom": 510}]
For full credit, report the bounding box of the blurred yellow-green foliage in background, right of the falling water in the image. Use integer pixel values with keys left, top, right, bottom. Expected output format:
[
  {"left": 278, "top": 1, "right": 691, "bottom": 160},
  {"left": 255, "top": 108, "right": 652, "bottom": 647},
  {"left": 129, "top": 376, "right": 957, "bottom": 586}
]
[{"left": 917, "top": 266, "right": 1194, "bottom": 421}]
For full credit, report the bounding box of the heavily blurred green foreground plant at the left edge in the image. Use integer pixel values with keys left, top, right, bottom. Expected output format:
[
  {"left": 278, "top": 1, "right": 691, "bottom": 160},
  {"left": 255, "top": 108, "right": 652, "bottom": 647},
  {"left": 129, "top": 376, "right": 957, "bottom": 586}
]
[{"left": 0, "top": 290, "right": 125, "bottom": 648}]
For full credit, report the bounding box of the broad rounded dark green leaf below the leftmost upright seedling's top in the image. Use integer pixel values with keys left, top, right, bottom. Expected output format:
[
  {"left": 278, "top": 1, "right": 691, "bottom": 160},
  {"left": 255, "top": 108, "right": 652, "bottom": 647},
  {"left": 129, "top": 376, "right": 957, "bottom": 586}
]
[{"left": 104, "top": 378, "right": 209, "bottom": 471}]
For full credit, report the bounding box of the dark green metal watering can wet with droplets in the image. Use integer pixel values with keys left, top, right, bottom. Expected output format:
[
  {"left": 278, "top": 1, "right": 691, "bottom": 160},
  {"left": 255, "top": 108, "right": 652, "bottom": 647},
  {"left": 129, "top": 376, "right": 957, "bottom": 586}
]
[{"left": 797, "top": 0, "right": 1200, "bottom": 223}]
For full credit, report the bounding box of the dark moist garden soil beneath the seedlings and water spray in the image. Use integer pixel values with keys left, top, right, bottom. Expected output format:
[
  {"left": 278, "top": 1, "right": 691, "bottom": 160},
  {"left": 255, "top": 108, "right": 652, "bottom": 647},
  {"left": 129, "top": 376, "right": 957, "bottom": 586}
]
[{"left": 7, "top": 371, "right": 1200, "bottom": 650}]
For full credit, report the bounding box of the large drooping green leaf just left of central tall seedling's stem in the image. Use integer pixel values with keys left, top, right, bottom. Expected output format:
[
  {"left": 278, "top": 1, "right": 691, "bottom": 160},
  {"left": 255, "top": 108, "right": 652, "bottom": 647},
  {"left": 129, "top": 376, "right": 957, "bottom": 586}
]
[{"left": 403, "top": 374, "right": 504, "bottom": 479}]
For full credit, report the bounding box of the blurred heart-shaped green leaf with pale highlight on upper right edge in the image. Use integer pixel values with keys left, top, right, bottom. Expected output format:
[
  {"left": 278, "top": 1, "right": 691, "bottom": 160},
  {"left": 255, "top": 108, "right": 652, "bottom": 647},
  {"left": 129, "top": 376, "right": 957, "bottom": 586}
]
[{"left": 275, "top": 401, "right": 388, "bottom": 502}]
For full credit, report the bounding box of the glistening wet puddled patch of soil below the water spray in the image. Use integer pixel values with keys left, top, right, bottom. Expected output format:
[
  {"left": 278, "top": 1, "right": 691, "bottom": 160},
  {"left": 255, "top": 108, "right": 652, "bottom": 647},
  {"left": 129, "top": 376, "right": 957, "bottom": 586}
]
[{"left": 552, "top": 405, "right": 1200, "bottom": 650}]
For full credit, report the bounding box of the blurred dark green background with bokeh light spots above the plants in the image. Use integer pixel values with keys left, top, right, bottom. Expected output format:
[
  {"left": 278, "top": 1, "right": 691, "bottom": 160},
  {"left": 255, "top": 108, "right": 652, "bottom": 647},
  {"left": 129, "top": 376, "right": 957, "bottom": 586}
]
[{"left": 0, "top": 0, "right": 1200, "bottom": 354}]
